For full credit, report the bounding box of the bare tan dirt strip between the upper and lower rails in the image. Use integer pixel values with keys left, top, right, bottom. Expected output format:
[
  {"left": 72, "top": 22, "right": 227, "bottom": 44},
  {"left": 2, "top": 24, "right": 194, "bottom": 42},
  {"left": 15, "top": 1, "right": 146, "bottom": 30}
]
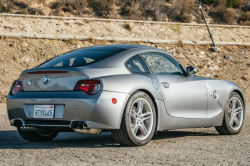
[{"left": 0, "top": 16, "right": 250, "bottom": 42}]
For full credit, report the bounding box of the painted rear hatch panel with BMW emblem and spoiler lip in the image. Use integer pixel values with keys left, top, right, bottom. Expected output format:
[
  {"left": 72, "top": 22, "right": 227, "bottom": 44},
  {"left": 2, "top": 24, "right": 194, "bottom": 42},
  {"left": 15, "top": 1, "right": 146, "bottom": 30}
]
[{"left": 19, "top": 67, "right": 89, "bottom": 91}]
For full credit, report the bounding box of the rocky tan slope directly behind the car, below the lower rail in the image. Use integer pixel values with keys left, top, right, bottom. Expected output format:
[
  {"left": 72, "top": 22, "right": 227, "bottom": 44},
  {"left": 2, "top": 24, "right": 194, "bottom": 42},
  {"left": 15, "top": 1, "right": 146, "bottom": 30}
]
[{"left": 0, "top": 38, "right": 250, "bottom": 102}]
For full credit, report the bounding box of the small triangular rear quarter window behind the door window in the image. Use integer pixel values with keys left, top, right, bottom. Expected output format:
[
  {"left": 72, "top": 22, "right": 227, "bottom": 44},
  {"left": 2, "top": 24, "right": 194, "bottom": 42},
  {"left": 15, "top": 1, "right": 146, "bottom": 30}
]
[{"left": 125, "top": 55, "right": 149, "bottom": 73}]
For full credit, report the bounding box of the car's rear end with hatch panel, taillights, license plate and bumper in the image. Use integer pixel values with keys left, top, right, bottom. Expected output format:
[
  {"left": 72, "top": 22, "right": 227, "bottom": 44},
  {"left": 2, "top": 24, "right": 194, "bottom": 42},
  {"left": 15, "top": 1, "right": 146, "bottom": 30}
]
[{"left": 7, "top": 45, "right": 128, "bottom": 134}]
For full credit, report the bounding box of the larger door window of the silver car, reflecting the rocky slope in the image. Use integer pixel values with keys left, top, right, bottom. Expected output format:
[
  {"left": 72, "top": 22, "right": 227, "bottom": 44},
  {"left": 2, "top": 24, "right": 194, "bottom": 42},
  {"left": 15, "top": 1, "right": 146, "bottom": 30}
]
[{"left": 141, "top": 53, "right": 183, "bottom": 75}]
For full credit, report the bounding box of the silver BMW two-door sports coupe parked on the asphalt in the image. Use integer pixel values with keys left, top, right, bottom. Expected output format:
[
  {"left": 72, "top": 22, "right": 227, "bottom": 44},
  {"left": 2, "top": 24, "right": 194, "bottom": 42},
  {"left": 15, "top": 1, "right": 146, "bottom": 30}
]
[{"left": 7, "top": 44, "right": 245, "bottom": 146}]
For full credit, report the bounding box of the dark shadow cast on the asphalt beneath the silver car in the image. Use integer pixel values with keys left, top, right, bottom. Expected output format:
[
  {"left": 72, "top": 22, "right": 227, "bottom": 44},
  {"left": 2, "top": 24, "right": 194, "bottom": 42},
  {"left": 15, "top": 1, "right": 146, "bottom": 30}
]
[{"left": 0, "top": 130, "right": 218, "bottom": 149}]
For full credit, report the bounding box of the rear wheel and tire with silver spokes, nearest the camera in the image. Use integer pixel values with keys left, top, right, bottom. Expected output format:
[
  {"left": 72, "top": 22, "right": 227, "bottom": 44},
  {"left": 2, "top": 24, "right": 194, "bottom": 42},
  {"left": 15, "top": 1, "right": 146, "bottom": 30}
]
[{"left": 111, "top": 91, "right": 156, "bottom": 146}]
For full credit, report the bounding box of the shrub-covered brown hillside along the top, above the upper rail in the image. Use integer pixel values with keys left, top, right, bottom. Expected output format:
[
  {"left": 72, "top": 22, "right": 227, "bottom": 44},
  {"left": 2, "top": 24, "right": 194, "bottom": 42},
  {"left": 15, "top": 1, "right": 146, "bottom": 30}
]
[{"left": 0, "top": 0, "right": 250, "bottom": 25}]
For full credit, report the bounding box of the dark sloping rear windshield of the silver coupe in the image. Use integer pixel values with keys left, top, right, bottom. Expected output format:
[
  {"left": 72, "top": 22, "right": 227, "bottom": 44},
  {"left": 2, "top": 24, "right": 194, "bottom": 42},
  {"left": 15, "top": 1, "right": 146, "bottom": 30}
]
[{"left": 37, "top": 47, "right": 126, "bottom": 68}]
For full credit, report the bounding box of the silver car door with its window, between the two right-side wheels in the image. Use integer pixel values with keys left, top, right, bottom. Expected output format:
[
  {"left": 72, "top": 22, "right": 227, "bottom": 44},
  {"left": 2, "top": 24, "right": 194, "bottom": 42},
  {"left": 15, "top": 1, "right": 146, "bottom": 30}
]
[{"left": 141, "top": 52, "right": 207, "bottom": 118}]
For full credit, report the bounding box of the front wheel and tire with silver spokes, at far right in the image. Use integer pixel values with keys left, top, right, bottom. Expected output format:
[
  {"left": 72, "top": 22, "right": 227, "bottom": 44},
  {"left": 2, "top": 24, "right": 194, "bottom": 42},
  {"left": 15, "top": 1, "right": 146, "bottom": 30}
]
[{"left": 215, "top": 92, "right": 245, "bottom": 135}]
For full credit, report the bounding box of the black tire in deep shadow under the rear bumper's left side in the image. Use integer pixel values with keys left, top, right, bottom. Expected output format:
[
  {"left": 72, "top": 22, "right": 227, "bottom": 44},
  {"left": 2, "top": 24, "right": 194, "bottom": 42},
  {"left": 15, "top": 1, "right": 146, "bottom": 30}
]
[{"left": 17, "top": 127, "right": 58, "bottom": 142}]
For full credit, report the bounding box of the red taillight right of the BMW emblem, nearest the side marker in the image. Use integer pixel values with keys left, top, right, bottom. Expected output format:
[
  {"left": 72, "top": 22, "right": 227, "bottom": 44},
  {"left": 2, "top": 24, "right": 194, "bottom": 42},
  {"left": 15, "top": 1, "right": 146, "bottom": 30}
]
[{"left": 75, "top": 80, "right": 101, "bottom": 95}]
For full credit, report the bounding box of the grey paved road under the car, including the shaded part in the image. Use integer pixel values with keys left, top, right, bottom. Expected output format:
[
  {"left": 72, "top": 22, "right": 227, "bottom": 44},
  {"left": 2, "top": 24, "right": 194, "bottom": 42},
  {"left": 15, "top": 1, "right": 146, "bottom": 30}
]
[{"left": 0, "top": 105, "right": 250, "bottom": 165}]
